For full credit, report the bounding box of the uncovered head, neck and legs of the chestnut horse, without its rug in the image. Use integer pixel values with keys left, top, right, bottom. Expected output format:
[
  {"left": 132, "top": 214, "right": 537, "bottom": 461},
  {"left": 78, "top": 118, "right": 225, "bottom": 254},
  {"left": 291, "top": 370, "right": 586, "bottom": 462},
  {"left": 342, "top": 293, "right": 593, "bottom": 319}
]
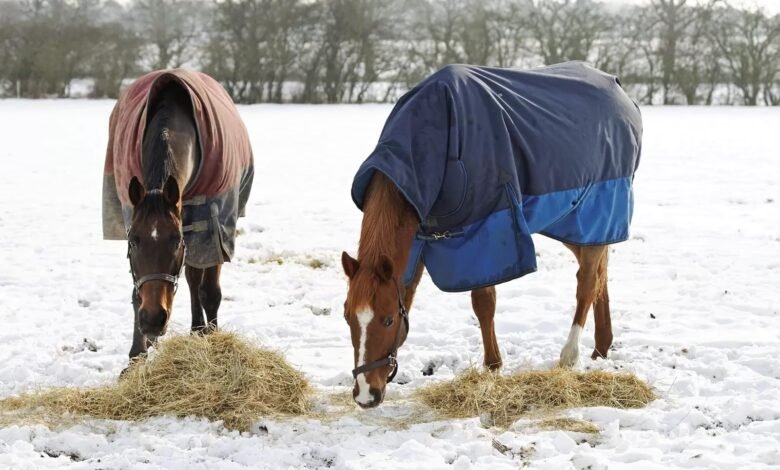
[{"left": 341, "top": 172, "right": 612, "bottom": 408}]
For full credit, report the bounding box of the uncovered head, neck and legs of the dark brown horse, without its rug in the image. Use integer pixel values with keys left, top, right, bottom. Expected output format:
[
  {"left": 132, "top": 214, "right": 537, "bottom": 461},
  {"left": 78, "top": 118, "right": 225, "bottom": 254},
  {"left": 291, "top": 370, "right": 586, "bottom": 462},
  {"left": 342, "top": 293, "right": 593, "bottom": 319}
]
[{"left": 128, "top": 85, "right": 222, "bottom": 359}]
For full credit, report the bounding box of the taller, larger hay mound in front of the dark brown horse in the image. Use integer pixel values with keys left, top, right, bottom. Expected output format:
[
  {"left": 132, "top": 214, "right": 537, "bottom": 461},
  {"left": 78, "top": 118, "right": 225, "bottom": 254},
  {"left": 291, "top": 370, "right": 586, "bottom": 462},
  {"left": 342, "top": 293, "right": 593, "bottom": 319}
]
[{"left": 0, "top": 332, "right": 311, "bottom": 431}]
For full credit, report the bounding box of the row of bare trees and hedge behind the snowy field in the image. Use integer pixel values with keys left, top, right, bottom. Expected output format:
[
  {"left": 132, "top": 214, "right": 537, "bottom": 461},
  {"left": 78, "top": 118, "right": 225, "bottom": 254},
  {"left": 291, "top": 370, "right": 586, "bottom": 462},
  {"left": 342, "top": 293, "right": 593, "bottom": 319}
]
[{"left": 0, "top": 0, "right": 780, "bottom": 105}]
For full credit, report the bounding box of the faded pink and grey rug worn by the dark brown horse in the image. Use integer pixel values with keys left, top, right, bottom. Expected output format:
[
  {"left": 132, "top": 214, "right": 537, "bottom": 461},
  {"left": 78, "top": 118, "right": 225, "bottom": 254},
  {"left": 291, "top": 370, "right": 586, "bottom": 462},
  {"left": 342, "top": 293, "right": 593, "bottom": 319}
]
[{"left": 103, "top": 69, "right": 254, "bottom": 268}]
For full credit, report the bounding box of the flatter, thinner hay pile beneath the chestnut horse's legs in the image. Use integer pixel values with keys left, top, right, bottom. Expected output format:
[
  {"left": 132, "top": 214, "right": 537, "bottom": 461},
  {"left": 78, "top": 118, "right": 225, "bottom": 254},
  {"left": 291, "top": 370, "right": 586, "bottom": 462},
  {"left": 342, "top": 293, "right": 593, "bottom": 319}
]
[{"left": 417, "top": 368, "right": 655, "bottom": 426}]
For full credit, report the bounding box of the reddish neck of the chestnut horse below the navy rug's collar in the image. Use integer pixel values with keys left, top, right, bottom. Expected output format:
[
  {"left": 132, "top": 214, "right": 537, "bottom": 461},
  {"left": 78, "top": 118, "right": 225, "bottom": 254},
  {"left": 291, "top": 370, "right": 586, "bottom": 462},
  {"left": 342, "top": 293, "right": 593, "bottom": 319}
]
[{"left": 358, "top": 172, "right": 418, "bottom": 278}]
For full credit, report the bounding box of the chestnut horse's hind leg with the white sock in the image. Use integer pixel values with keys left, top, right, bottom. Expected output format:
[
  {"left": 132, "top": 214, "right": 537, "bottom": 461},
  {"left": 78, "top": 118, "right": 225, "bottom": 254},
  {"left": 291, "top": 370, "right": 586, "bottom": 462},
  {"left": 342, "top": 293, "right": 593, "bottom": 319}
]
[{"left": 559, "top": 245, "right": 607, "bottom": 367}]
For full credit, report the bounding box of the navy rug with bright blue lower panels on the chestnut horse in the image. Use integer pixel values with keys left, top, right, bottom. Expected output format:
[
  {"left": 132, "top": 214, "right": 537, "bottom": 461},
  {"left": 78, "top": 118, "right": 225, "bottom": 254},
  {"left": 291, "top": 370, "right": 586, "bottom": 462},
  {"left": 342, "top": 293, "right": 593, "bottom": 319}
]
[{"left": 352, "top": 62, "right": 642, "bottom": 291}]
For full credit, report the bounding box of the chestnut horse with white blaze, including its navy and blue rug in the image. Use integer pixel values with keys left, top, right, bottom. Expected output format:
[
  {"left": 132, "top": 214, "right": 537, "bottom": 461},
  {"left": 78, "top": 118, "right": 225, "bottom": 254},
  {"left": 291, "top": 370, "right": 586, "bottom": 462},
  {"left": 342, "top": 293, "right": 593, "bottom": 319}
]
[{"left": 341, "top": 63, "right": 642, "bottom": 408}]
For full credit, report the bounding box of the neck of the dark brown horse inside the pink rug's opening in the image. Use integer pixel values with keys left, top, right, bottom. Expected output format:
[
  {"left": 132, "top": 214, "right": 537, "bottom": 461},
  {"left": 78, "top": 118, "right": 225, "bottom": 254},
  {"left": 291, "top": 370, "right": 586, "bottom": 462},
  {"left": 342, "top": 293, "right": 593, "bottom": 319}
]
[{"left": 141, "top": 92, "right": 200, "bottom": 196}]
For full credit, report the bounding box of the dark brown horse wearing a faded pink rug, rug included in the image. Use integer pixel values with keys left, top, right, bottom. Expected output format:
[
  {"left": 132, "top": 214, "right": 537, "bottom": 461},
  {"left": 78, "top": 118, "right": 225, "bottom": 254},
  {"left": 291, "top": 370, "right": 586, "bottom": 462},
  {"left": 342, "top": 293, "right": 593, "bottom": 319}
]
[{"left": 103, "top": 70, "right": 253, "bottom": 370}]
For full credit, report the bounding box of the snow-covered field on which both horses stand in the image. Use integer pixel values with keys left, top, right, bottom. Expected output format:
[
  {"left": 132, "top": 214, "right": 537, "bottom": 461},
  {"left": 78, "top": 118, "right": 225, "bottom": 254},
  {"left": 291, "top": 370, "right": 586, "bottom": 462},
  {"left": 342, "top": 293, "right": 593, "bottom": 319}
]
[{"left": 0, "top": 101, "right": 780, "bottom": 470}]
